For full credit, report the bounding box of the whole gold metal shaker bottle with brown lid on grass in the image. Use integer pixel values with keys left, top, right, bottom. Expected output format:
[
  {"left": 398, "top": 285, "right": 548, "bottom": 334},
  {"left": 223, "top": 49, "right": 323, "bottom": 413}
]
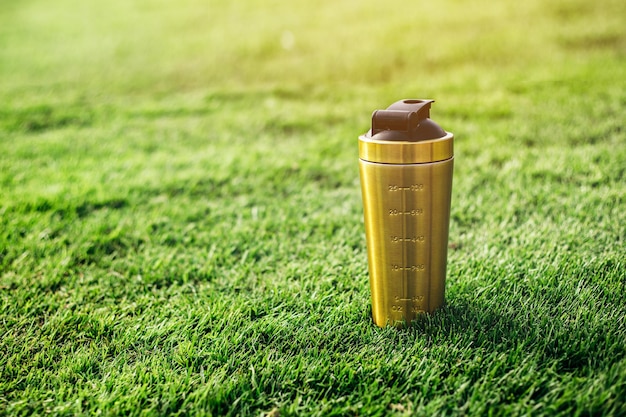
[{"left": 359, "top": 100, "right": 454, "bottom": 327}]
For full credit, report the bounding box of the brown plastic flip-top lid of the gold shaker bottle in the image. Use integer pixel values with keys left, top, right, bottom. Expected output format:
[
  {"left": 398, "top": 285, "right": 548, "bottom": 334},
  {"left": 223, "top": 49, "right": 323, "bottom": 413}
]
[{"left": 367, "top": 99, "right": 446, "bottom": 142}]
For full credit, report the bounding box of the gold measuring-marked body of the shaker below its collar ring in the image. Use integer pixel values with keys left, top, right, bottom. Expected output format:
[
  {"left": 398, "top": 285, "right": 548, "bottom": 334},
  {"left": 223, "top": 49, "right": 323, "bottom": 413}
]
[{"left": 359, "top": 157, "right": 454, "bottom": 326}]
